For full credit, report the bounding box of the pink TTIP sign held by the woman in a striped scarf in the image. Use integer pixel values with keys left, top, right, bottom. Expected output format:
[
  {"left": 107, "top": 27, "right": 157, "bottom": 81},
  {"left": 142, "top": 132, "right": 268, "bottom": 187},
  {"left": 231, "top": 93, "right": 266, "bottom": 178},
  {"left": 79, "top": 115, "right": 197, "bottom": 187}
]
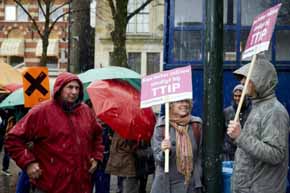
[{"left": 141, "top": 66, "right": 192, "bottom": 108}]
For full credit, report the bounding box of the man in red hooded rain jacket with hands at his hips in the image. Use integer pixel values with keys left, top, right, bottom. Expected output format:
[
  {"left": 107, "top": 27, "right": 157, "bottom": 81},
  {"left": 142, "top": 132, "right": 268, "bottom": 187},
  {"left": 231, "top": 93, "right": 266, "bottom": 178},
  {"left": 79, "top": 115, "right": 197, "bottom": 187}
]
[{"left": 5, "top": 72, "right": 104, "bottom": 193}]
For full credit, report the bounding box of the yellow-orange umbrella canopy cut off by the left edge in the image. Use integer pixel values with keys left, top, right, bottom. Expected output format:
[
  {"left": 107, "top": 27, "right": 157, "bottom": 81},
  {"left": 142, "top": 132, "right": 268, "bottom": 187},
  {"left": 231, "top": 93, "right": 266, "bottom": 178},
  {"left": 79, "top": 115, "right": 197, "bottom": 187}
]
[{"left": 0, "top": 62, "right": 22, "bottom": 87}]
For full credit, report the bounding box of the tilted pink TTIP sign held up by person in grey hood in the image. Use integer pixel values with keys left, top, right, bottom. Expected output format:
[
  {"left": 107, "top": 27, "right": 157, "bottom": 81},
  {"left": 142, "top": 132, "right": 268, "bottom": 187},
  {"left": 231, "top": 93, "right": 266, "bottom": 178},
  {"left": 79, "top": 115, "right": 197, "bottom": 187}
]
[{"left": 243, "top": 3, "right": 282, "bottom": 59}]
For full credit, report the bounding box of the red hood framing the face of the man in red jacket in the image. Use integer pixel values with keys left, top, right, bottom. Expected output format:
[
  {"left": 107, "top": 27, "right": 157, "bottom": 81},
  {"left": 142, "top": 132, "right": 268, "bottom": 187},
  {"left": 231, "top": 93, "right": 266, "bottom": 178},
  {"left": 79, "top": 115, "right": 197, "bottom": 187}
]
[{"left": 53, "top": 72, "right": 84, "bottom": 101}]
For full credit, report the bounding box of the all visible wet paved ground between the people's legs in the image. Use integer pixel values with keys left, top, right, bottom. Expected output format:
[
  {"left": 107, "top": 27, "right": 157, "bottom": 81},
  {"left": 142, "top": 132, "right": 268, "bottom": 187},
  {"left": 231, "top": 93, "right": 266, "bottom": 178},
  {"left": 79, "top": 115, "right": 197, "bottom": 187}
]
[{"left": 0, "top": 152, "right": 153, "bottom": 193}]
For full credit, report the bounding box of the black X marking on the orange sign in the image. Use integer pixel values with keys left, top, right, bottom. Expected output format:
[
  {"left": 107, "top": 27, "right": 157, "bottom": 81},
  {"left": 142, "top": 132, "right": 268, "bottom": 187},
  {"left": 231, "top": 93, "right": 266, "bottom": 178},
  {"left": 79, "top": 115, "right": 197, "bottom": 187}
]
[{"left": 24, "top": 72, "right": 48, "bottom": 96}]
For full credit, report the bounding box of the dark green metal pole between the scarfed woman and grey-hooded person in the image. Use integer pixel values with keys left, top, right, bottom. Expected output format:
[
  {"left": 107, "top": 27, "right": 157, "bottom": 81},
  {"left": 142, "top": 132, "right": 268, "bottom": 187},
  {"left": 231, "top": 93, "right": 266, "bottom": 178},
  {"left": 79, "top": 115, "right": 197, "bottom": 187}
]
[{"left": 203, "top": 0, "right": 224, "bottom": 193}]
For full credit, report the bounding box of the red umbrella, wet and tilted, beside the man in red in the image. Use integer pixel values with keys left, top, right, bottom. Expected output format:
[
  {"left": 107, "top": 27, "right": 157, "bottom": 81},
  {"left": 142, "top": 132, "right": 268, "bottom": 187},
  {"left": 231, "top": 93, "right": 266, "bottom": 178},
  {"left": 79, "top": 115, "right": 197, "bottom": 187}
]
[{"left": 87, "top": 80, "right": 156, "bottom": 140}]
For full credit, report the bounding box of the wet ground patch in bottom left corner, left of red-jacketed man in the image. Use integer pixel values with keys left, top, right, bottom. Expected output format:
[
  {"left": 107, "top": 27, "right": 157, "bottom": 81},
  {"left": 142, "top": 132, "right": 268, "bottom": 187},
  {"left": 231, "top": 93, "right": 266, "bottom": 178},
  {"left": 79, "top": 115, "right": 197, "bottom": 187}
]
[{"left": 0, "top": 152, "right": 20, "bottom": 193}]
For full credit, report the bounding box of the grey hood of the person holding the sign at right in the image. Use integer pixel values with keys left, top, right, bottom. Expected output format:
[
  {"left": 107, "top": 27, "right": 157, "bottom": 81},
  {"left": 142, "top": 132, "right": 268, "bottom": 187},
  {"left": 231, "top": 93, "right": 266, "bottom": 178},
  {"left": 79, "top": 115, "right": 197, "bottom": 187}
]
[{"left": 234, "top": 55, "right": 278, "bottom": 99}]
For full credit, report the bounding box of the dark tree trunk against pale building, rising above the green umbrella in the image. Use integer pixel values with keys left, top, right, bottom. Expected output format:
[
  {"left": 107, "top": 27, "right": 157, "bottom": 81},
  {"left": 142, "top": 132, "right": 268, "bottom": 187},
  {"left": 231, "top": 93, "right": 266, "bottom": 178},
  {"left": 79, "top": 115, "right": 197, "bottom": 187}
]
[{"left": 110, "top": 0, "right": 128, "bottom": 68}]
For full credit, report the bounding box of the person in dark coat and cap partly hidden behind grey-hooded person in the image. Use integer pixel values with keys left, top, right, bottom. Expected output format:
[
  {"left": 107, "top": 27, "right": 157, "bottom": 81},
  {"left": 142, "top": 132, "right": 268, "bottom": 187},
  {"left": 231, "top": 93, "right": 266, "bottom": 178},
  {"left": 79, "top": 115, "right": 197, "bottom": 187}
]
[{"left": 223, "top": 84, "right": 251, "bottom": 161}]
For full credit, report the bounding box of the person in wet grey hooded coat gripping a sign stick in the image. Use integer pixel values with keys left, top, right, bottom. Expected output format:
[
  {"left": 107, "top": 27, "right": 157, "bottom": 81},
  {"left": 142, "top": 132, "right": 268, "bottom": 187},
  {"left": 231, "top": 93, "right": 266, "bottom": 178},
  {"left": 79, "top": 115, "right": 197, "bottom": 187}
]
[{"left": 227, "top": 56, "right": 289, "bottom": 193}]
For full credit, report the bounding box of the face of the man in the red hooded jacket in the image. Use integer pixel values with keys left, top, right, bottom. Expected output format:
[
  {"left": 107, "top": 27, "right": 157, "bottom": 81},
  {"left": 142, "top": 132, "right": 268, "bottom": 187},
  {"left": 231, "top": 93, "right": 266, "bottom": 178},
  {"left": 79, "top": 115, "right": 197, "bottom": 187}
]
[{"left": 60, "top": 80, "right": 80, "bottom": 103}]
